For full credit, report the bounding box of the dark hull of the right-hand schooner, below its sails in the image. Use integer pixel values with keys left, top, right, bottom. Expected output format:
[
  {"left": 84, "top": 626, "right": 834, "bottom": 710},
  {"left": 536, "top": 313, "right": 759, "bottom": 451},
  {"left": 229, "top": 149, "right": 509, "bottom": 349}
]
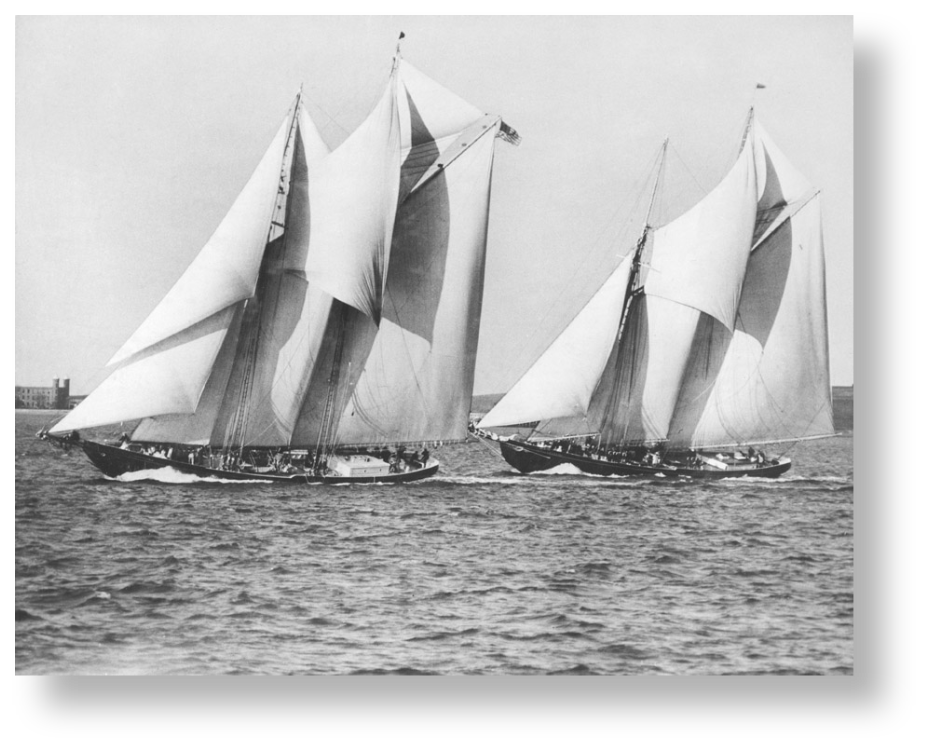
[{"left": 500, "top": 440, "right": 791, "bottom": 479}]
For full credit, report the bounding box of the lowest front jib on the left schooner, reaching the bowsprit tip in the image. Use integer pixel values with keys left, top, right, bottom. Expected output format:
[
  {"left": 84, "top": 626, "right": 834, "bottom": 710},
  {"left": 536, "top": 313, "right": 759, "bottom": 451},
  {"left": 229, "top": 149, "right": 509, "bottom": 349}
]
[{"left": 51, "top": 306, "right": 235, "bottom": 433}]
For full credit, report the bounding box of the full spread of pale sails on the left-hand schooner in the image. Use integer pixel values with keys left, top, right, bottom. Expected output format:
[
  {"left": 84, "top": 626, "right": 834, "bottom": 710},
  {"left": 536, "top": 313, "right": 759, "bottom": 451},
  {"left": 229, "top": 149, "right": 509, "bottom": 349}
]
[{"left": 50, "top": 57, "right": 516, "bottom": 451}]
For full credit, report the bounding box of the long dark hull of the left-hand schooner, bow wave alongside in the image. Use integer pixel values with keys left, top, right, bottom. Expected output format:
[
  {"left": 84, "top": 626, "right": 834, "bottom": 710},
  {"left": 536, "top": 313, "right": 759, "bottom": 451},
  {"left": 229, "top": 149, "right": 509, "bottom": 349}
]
[{"left": 79, "top": 440, "right": 439, "bottom": 485}]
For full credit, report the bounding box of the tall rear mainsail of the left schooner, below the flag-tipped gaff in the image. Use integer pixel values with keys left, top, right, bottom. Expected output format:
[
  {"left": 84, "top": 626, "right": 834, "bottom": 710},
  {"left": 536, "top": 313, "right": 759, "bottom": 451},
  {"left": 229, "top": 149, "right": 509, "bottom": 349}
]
[{"left": 338, "top": 122, "right": 496, "bottom": 444}]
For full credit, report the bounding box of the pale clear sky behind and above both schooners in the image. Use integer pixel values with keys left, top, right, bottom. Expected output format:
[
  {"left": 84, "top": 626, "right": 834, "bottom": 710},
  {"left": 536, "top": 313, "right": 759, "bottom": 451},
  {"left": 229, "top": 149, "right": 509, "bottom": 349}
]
[{"left": 15, "top": 15, "right": 854, "bottom": 394}]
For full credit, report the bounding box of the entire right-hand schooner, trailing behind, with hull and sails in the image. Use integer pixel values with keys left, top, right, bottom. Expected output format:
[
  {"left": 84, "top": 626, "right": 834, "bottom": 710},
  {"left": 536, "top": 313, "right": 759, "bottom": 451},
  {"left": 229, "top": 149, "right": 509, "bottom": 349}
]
[{"left": 474, "top": 111, "right": 833, "bottom": 477}]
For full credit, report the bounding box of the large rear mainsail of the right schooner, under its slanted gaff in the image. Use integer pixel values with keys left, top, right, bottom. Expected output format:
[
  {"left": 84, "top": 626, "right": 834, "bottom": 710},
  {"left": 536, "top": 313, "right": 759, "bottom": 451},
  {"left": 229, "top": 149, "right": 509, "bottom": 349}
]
[{"left": 669, "top": 195, "right": 833, "bottom": 446}]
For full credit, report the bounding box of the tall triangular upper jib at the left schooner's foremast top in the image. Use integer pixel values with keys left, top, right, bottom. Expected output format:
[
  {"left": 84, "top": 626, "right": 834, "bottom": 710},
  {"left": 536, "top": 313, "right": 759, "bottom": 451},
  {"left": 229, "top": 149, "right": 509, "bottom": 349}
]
[{"left": 108, "top": 113, "right": 292, "bottom": 365}]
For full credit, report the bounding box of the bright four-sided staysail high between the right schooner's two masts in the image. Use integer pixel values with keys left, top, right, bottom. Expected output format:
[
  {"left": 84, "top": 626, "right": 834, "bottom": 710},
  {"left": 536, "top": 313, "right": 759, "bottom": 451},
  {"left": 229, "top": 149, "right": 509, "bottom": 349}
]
[{"left": 645, "top": 142, "right": 758, "bottom": 331}]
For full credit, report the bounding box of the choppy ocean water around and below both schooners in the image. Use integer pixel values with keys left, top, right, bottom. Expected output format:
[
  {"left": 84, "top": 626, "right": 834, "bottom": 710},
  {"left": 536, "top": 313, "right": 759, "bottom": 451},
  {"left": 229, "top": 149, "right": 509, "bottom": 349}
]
[{"left": 15, "top": 411, "right": 855, "bottom": 675}]
